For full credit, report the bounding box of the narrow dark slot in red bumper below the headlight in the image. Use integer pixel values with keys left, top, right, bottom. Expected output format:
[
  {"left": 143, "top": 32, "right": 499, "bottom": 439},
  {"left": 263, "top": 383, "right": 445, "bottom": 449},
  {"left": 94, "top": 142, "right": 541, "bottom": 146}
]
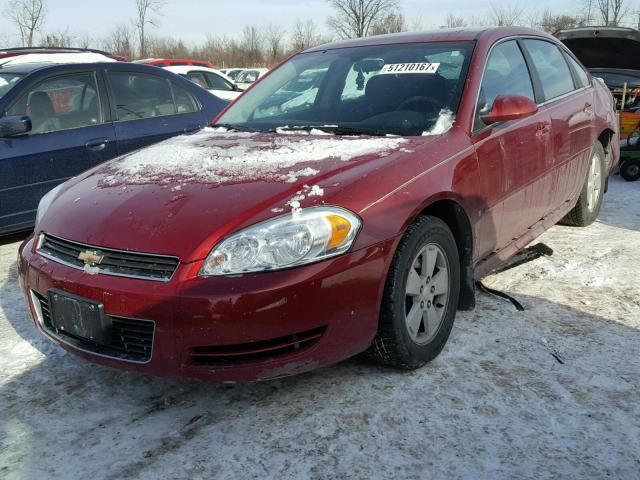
[{"left": 190, "top": 327, "right": 326, "bottom": 365}]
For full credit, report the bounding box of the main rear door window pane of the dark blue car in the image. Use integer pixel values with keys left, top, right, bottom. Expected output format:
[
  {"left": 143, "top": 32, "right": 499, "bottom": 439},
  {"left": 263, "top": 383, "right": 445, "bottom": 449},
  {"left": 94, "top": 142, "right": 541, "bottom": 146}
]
[{"left": 107, "top": 72, "right": 179, "bottom": 121}]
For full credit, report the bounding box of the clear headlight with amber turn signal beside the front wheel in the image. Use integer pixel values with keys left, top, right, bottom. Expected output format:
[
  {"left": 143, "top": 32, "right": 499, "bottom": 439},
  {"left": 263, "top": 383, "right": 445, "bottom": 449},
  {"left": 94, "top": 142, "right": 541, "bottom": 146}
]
[{"left": 200, "top": 207, "right": 361, "bottom": 276}]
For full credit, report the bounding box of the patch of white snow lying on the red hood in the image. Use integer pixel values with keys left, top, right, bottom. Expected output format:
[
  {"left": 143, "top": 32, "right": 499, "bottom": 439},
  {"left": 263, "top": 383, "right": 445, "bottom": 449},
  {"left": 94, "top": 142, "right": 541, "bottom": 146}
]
[{"left": 100, "top": 128, "right": 406, "bottom": 186}]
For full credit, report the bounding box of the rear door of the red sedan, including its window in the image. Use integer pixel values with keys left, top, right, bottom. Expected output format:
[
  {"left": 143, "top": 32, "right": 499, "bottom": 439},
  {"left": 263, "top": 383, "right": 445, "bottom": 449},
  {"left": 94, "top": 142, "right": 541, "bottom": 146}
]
[{"left": 522, "top": 39, "right": 594, "bottom": 214}]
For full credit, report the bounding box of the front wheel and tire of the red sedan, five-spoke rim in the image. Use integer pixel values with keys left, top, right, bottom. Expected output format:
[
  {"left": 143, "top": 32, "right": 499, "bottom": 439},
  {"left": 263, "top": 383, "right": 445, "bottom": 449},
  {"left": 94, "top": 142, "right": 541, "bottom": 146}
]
[{"left": 367, "top": 216, "right": 460, "bottom": 370}]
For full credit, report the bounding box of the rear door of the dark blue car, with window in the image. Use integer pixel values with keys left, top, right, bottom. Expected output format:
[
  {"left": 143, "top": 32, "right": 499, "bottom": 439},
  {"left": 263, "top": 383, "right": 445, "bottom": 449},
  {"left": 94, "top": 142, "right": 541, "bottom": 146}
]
[{"left": 106, "top": 70, "right": 208, "bottom": 155}]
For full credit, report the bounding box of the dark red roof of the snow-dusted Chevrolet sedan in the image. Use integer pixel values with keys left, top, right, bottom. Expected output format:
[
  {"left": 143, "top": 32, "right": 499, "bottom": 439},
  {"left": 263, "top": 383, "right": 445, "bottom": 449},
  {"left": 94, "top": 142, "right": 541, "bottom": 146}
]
[{"left": 306, "top": 27, "right": 550, "bottom": 52}]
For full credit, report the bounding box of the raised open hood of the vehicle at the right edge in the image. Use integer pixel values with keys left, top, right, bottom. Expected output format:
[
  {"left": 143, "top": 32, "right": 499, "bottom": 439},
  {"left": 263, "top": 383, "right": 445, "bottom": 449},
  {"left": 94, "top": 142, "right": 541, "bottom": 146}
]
[{"left": 556, "top": 27, "right": 640, "bottom": 70}]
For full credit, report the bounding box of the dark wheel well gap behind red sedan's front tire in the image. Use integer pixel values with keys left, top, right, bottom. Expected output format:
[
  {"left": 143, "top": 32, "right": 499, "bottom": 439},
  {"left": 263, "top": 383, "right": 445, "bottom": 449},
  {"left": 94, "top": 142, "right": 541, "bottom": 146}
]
[{"left": 420, "top": 200, "right": 476, "bottom": 310}]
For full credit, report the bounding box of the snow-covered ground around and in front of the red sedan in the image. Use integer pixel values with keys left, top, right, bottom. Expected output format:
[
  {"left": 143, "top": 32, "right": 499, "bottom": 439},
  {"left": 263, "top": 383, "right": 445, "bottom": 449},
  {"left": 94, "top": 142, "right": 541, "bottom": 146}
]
[{"left": 0, "top": 178, "right": 640, "bottom": 480}]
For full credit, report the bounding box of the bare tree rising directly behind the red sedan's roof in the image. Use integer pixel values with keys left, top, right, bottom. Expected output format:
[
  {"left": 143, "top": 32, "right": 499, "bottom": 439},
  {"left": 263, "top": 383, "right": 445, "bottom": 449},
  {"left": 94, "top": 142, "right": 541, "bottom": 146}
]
[{"left": 327, "top": 0, "right": 400, "bottom": 38}]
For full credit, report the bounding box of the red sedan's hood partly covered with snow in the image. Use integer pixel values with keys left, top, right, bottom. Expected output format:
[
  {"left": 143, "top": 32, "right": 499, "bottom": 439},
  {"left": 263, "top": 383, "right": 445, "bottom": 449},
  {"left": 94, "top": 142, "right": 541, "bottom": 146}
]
[{"left": 39, "top": 128, "right": 428, "bottom": 262}]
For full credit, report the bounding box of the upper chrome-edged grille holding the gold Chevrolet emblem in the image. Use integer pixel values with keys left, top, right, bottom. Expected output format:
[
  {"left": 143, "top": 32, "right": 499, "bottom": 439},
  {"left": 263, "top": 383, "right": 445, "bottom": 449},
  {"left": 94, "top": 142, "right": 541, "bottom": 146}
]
[{"left": 38, "top": 234, "right": 179, "bottom": 281}]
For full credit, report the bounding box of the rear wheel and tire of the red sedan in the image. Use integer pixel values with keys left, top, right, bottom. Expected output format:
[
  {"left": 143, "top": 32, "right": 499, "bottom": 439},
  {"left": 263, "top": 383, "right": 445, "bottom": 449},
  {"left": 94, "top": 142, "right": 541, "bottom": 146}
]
[{"left": 560, "top": 142, "right": 607, "bottom": 227}]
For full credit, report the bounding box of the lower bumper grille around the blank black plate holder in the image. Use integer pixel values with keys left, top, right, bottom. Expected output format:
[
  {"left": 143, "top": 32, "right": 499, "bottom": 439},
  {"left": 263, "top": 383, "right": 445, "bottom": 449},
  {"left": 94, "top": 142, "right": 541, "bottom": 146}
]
[{"left": 33, "top": 292, "right": 155, "bottom": 363}]
